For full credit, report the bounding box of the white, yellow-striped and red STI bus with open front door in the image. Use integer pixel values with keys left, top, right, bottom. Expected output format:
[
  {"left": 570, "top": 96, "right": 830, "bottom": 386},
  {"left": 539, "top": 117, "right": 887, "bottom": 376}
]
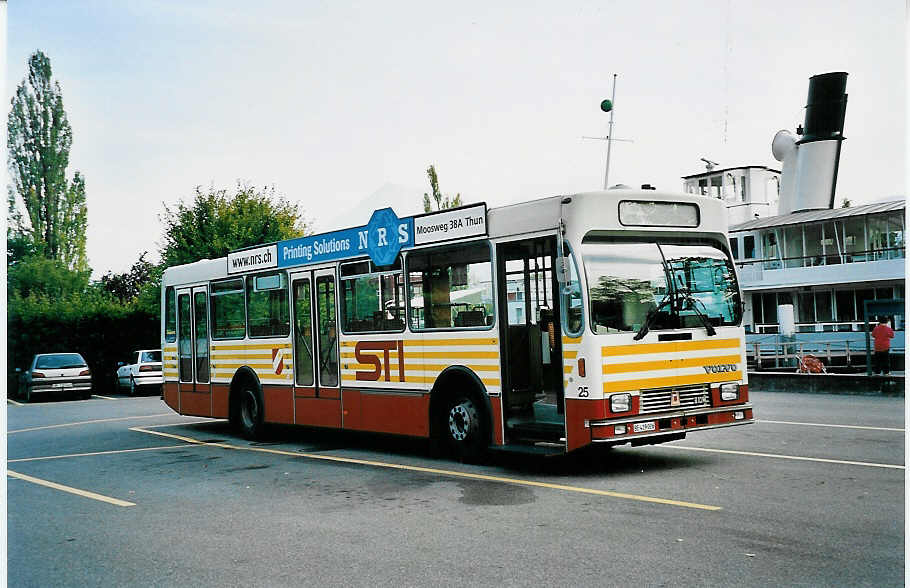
[{"left": 161, "top": 189, "right": 754, "bottom": 459}]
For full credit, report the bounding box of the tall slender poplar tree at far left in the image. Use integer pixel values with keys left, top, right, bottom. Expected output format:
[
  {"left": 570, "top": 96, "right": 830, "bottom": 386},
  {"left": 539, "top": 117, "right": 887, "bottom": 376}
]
[{"left": 7, "top": 51, "right": 88, "bottom": 271}]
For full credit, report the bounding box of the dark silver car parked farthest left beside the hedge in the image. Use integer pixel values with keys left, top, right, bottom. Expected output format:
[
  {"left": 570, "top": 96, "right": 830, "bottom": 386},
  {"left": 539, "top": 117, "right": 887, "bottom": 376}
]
[{"left": 16, "top": 353, "right": 92, "bottom": 402}]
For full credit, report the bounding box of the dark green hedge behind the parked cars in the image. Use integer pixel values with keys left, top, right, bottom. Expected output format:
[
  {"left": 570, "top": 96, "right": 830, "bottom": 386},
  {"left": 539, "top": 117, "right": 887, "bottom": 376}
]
[{"left": 7, "top": 292, "right": 161, "bottom": 393}]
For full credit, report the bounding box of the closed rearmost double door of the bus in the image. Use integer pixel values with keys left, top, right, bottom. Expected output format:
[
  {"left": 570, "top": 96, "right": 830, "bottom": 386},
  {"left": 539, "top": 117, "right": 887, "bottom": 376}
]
[{"left": 177, "top": 286, "right": 212, "bottom": 416}]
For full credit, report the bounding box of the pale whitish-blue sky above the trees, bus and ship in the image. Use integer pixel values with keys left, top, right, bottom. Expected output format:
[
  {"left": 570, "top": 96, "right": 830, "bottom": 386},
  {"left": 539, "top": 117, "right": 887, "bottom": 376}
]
[{"left": 5, "top": 0, "right": 908, "bottom": 278}]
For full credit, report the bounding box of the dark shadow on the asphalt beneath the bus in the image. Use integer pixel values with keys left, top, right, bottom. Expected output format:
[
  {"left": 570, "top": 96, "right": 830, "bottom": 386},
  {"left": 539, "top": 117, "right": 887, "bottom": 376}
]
[{"left": 173, "top": 421, "right": 712, "bottom": 477}]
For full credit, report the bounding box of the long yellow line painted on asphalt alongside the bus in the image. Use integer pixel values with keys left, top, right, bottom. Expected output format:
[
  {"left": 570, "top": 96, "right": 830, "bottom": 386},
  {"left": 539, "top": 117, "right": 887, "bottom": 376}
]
[{"left": 130, "top": 427, "right": 722, "bottom": 511}]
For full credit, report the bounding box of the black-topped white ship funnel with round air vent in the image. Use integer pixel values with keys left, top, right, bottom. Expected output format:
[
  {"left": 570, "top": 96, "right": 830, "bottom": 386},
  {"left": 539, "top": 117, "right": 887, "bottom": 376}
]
[{"left": 771, "top": 72, "right": 847, "bottom": 214}]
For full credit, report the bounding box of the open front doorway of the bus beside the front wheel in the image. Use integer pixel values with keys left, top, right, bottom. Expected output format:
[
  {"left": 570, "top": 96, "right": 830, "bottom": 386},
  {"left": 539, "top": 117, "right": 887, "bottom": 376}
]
[{"left": 496, "top": 237, "right": 565, "bottom": 441}]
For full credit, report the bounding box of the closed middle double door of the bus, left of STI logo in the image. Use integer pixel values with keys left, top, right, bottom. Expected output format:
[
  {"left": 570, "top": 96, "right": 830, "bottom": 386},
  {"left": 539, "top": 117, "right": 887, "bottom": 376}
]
[{"left": 291, "top": 269, "right": 341, "bottom": 427}]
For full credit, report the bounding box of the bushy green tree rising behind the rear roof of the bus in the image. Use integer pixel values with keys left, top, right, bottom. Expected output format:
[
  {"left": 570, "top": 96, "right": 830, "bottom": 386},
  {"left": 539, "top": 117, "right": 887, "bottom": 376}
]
[{"left": 160, "top": 182, "right": 309, "bottom": 267}]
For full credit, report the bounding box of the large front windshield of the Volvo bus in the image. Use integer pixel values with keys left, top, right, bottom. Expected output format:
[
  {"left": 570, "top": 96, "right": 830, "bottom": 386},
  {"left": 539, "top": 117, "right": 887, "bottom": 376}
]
[{"left": 582, "top": 240, "right": 742, "bottom": 334}]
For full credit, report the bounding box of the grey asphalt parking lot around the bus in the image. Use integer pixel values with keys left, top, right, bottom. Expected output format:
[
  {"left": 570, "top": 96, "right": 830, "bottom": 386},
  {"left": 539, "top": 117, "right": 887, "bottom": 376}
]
[{"left": 7, "top": 392, "right": 905, "bottom": 586}]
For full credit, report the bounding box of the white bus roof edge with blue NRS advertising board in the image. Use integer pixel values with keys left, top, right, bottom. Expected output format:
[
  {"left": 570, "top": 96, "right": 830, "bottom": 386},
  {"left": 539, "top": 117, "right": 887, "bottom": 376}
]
[{"left": 165, "top": 189, "right": 727, "bottom": 284}]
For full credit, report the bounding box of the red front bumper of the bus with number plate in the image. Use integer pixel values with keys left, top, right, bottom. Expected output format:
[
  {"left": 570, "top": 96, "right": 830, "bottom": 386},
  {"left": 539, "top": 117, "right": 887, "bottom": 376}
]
[{"left": 588, "top": 402, "right": 755, "bottom": 443}]
